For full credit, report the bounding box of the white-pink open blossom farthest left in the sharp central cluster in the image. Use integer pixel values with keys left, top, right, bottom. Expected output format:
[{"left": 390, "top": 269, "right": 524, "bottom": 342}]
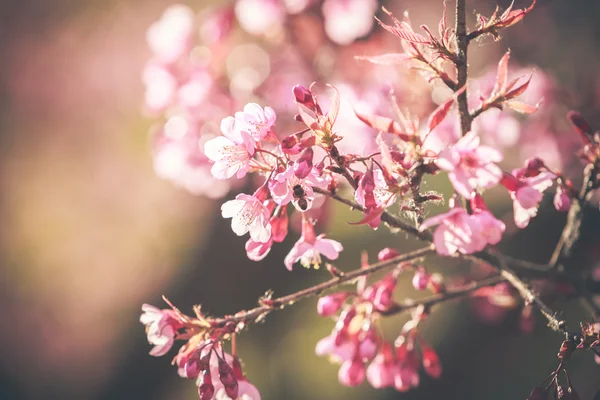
[{"left": 204, "top": 117, "right": 254, "bottom": 179}]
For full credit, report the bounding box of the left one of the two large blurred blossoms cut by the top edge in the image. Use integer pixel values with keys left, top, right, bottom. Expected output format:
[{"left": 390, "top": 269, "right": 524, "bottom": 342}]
[{"left": 235, "top": 0, "right": 285, "bottom": 35}]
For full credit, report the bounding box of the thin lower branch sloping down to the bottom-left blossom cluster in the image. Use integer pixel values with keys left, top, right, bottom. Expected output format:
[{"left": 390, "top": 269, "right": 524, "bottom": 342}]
[{"left": 211, "top": 246, "right": 435, "bottom": 326}]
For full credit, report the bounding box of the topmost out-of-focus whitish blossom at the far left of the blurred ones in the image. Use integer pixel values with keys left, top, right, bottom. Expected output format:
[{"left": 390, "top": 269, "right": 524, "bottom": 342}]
[{"left": 146, "top": 4, "right": 194, "bottom": 64}]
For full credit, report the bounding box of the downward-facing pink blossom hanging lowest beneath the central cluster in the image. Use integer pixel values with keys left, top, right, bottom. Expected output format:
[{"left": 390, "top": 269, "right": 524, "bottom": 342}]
[{"left": 284, "top": 219, "right": 344, "bottom": 271}]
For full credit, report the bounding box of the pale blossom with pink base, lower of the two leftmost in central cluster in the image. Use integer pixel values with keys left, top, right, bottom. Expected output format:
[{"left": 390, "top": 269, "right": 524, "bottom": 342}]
[{"left": 221, "top": 186, "right": 271, "bottom": 243}]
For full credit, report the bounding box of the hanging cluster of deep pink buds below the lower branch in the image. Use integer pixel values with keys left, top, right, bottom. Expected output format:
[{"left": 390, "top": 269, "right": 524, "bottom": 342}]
[{"left": 316, "top": 248, "right": 445, "bottom": 392}]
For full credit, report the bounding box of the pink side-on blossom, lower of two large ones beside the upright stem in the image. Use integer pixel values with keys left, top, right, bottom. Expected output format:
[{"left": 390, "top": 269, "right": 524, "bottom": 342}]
[{"left": 419, "top": 207, "right": 487, "bottom": 256}]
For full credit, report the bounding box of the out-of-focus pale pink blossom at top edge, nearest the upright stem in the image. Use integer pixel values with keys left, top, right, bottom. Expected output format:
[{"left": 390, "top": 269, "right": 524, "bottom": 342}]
[{"left": 323, "top": 0, "right": 378, "bottom": 45}]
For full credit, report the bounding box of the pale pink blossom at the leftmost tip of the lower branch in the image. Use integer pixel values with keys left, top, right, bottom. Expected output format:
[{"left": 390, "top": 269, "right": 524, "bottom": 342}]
[{"left": 140, "top": 304, "right": 181, "bottom": 357}]
